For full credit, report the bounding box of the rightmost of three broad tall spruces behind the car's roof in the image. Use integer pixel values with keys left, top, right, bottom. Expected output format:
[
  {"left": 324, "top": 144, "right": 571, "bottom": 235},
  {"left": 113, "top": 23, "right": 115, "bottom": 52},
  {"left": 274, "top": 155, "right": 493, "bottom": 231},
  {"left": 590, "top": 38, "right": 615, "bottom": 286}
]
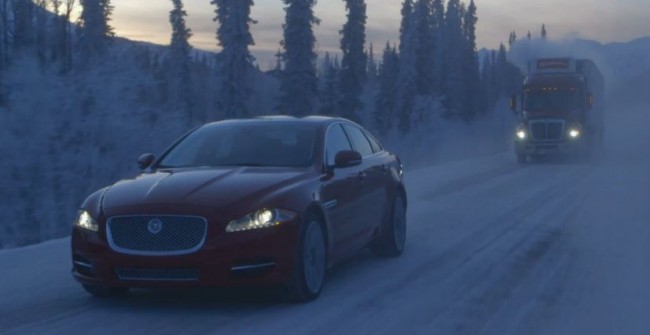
[{"left": 340, "top": 0, "right": 368, "bottom": 121}]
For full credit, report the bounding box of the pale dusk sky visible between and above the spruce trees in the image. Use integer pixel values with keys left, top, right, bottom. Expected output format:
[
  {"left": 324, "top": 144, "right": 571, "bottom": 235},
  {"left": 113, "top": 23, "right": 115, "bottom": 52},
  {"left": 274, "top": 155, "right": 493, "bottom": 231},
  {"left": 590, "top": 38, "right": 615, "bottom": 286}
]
[{"left": 112, "top": 0, "right": 650, "bottom": 68}]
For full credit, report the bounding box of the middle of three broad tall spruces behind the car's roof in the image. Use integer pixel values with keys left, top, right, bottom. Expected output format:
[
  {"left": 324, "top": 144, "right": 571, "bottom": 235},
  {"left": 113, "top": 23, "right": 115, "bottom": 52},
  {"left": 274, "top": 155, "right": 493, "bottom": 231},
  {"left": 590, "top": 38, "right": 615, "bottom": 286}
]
[{"left": 277, "top": 0, "right": 319, "bottom": 116}]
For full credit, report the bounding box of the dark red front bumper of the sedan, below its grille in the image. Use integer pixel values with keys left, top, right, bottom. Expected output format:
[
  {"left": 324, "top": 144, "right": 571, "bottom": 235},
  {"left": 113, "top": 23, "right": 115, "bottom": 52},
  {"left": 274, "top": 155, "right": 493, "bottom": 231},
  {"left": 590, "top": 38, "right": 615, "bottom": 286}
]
[{"left": 72, "top": 219, "right": 299, "bottom": 287}]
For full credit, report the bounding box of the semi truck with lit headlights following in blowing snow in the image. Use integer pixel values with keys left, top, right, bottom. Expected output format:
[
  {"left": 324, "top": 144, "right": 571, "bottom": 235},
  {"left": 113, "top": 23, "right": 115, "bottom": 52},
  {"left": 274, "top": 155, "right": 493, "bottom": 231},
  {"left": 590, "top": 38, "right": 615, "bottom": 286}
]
[{"left": 510, "top": 57, "right": 605, "bottom": 164}]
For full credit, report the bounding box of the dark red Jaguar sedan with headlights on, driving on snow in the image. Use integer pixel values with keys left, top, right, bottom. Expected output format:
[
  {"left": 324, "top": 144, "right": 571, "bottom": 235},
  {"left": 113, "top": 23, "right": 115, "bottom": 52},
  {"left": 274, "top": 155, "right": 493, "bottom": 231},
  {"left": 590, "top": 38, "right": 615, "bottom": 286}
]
[{"left": 72, "top": 116, "right": 407, "bottom": 301}]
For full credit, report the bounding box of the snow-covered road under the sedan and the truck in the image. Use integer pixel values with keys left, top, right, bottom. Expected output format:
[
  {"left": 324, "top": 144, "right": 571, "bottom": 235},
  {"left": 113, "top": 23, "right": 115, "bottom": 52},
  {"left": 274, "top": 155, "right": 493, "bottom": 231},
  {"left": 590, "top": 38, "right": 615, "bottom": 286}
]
[{"left": 0, "top": 108, "right": 650, "bottom": 335}]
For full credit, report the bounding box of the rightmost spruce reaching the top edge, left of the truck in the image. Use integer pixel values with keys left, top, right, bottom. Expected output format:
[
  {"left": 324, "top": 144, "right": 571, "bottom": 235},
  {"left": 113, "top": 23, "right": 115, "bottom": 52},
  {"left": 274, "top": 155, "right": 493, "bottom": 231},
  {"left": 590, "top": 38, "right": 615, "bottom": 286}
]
[{"left": 462, "top": 0, "right": 480, "bottom": 120}]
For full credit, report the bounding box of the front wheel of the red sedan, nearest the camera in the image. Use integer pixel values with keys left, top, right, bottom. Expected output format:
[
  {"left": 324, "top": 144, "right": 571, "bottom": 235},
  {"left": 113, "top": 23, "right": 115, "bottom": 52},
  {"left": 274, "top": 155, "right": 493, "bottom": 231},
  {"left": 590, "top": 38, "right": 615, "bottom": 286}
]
[{"left": 288, "top": 215, "right": 327, "bottom": 302}]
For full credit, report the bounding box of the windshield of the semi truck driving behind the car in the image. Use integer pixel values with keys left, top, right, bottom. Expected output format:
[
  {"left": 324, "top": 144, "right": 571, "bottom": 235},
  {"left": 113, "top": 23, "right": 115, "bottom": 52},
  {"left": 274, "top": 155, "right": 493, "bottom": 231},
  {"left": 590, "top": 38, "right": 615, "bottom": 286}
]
[{"left": 524, "top": 88, "right": 580, "bottom": 110}]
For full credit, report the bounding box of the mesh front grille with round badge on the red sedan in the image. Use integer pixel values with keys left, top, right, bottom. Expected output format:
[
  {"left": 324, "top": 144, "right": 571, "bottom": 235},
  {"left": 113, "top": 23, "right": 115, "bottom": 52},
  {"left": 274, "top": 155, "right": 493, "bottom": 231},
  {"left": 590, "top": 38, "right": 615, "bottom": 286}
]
[{"left": 106, "top": 215, "right": 208, "bottom": 256}]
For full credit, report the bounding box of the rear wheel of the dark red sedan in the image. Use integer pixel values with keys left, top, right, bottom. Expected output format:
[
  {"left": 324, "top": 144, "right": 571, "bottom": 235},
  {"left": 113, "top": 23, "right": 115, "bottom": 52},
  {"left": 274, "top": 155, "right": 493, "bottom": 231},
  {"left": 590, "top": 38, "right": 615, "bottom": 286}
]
[{"left": 370, "top": 195, "right": 406, "bottom": 257}]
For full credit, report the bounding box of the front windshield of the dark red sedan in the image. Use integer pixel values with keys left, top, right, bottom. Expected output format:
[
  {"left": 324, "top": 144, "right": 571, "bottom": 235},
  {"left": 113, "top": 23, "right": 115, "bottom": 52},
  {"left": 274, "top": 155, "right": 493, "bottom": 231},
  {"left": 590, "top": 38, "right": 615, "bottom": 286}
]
[{"left": 157, "top": 122, "right": 316, "bottom": 168}]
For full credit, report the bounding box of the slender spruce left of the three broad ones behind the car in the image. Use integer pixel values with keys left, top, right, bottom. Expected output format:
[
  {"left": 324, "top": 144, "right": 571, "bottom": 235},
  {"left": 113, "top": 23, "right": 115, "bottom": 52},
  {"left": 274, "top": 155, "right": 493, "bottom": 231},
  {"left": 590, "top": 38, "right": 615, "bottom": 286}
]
[{"left": 169, "top": 0, "right": 194, "bottom": 124}]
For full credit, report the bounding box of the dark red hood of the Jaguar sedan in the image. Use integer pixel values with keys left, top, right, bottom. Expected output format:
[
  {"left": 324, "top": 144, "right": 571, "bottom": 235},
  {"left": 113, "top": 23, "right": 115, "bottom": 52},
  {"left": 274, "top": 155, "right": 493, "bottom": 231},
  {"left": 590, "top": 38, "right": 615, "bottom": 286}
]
[{"left": 102, "top": 167, "right": 314, "bottom": 212}]
